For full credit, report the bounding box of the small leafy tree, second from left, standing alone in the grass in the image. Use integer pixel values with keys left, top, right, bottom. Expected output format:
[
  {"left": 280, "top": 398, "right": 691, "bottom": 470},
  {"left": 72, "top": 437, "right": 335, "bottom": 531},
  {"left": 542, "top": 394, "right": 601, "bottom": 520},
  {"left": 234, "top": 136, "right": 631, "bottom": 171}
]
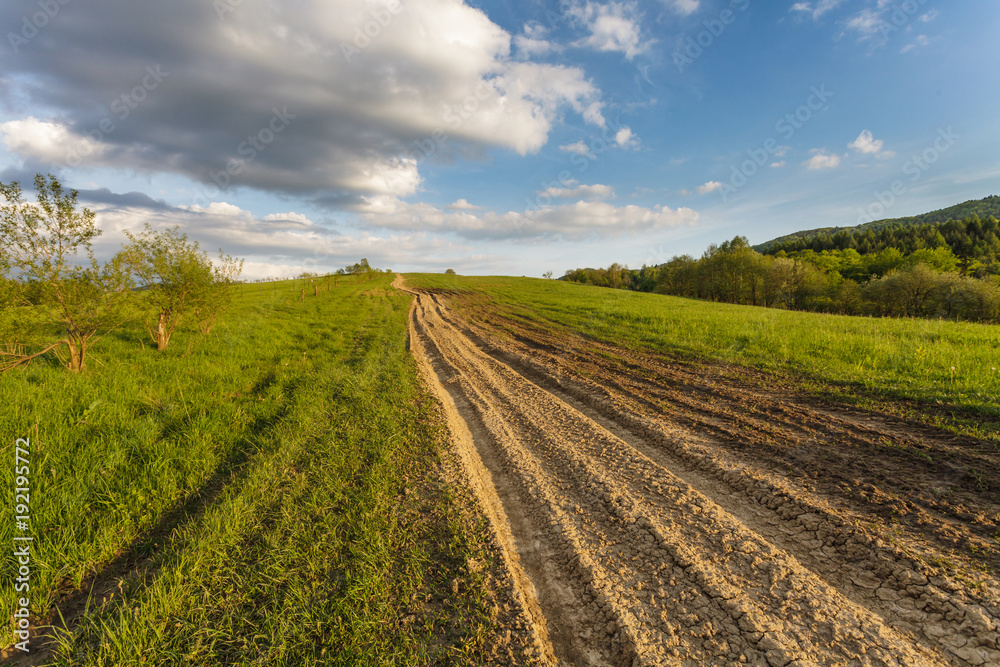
[{"left": 119, "top": 224, "right": 235, "bottom": 351}]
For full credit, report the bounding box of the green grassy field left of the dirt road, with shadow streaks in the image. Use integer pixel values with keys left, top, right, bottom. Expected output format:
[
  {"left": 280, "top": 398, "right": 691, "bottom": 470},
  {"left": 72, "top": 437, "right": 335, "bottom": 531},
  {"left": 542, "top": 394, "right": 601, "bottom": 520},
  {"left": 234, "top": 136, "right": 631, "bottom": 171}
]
[{"left": 0, "top": 277, "right": 500, "bottom": 665}]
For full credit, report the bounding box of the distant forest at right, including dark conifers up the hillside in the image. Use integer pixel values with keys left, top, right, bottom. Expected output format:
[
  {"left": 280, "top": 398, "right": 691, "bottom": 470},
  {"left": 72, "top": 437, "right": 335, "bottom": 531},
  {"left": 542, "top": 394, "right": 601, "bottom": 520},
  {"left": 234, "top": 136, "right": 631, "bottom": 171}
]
[{"left": 562, "top": 210, "right": 1000, "bottom": 323}]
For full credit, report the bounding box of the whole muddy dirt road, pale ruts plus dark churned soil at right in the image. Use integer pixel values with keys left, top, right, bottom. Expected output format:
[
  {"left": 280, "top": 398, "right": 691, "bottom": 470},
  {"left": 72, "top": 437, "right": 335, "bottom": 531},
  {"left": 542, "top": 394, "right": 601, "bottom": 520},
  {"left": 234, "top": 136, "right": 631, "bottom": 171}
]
[{"left": 397, "top": 279, "right": 1000, "bottom": 666}]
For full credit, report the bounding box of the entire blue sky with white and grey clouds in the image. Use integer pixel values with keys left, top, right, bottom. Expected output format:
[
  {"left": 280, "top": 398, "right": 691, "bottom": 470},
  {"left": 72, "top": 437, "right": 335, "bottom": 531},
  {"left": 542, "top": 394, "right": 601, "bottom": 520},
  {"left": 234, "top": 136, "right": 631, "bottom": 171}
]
[{"left": 0, "top": 0, "right": 1000, "bottom": 279}]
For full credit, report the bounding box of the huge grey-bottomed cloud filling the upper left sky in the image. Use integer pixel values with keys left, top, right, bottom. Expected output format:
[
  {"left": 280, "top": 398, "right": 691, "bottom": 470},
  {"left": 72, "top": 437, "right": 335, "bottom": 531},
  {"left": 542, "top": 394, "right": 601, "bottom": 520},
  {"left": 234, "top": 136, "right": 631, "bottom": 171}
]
[{"left": 0, "top": 0, "right": 608, "bottom": 205}]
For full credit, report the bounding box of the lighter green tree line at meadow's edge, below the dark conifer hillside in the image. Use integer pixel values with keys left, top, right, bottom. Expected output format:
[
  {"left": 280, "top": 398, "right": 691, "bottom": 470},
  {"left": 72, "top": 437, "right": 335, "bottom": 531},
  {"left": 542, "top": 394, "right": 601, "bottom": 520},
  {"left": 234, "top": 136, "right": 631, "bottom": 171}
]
[{"left": 563, "top": 230, "right": 1000, "bottom": 322}]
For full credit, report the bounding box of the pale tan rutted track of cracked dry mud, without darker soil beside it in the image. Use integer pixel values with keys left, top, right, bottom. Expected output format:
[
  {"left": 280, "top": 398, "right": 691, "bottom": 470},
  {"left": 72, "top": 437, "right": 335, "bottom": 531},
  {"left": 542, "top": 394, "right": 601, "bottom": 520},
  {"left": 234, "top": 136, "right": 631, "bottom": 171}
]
[{"left": 397, "top": 281, "right": 1000, "bottom": 666}]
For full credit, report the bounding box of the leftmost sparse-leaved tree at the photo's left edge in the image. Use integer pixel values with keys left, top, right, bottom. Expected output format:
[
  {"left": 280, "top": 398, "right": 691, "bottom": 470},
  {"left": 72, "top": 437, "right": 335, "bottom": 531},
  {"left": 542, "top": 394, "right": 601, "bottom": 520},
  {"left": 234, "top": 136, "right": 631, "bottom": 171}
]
[{"left": 0, "top": 174, "right": 131, "bottom": 372}]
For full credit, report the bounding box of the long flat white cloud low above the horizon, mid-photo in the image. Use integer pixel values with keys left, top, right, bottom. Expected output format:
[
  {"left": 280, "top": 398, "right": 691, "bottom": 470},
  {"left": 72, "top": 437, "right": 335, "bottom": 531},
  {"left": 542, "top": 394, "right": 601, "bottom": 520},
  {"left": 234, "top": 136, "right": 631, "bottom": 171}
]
[{"left": 359, "top": 197, "right": 698, "bottom": 240}]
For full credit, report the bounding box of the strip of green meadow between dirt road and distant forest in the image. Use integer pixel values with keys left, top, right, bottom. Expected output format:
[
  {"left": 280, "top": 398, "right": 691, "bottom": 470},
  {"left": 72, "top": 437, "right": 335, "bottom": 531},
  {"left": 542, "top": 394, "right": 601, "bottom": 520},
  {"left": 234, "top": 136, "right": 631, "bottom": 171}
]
[{"left": 407, "top": 274, "right": 1000, "bottom": 439}]
